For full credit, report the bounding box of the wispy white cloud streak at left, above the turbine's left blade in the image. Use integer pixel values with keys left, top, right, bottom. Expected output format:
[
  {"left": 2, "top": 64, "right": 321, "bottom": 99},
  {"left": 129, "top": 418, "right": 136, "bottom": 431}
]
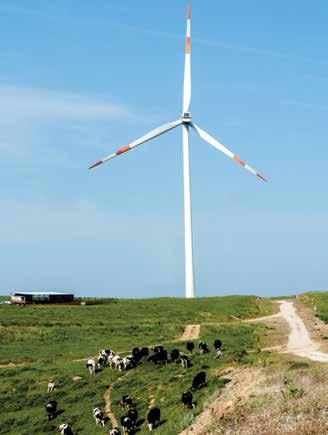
[{"left": 0, "top": 84, "right": 130, "bottom": 123}]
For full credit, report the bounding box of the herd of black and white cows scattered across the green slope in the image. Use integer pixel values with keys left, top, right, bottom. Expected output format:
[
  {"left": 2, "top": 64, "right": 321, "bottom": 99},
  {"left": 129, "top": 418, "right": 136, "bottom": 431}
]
[{"left": 46, "top": 339, "right": 223, "bottom": 435}]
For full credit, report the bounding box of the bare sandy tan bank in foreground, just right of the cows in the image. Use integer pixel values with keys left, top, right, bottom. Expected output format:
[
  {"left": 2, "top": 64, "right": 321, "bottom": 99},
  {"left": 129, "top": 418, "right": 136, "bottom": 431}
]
[{"left": 180, "top": 368, "right": 263, "bottom": 435}]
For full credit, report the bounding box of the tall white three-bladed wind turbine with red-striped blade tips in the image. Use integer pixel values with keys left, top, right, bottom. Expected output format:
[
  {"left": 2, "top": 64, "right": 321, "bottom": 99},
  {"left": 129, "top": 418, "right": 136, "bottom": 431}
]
[{"left": 89, "top": 0, "right": 267, "bottom": 298}]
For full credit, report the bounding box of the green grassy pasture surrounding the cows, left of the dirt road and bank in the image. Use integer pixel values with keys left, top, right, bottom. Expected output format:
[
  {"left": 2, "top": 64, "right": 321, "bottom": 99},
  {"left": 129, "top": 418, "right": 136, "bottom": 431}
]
[{"left": 0, "top": 296, "right": 271, "bottom": 435}]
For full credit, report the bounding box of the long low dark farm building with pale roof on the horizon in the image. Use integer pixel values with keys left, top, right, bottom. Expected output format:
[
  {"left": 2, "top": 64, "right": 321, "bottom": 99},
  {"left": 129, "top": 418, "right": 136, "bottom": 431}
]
[{"left": 10, "top": 292, "right": 74, "bottom": 305}]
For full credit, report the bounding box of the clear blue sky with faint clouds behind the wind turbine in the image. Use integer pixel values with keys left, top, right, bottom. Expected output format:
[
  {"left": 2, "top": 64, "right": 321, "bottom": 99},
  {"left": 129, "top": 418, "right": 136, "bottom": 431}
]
[{"left": 0, "top": 0, "right": 328, "bottom": 297}]
